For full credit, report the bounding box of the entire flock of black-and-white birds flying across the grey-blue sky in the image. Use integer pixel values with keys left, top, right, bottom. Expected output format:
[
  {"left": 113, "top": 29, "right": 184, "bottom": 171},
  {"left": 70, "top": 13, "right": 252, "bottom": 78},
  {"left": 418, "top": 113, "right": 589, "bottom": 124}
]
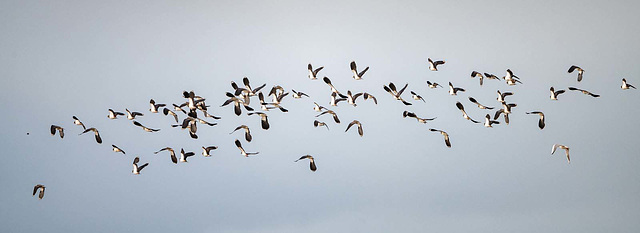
[{"left": 27, "top": 58, "right": 636, "bottom": 199}]
